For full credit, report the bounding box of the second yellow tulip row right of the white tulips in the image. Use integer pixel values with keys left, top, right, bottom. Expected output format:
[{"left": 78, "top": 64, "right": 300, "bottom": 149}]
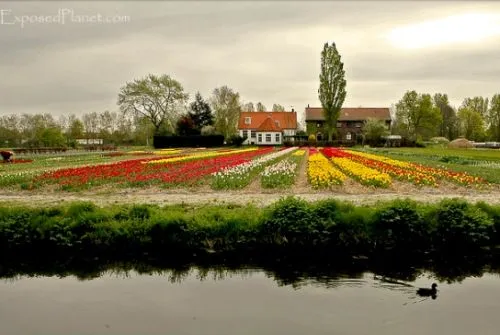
[{"left": 332, "top": 157, "right": 391, "bottom": 187}]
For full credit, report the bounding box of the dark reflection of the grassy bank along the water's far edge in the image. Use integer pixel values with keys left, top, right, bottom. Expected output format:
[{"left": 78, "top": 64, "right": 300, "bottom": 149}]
[{"left": 0, "top": 259, "right": 500, "bottom": 290}]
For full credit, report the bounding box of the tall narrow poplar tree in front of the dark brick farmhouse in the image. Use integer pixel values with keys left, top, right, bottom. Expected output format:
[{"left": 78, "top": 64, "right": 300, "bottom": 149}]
[{"left": 318, "top": 42, "right": 346, "bottom": 141}]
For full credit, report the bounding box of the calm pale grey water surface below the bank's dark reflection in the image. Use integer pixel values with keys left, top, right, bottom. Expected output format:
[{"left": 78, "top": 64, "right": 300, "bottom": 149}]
[{"left": 0, "top": 269, "right": 500, "bottom": 335}]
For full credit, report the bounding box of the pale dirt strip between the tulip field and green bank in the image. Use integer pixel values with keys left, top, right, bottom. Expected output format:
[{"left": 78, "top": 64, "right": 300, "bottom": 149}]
[{"left": 0, "top": 189, "right": 500, "bottom": 206}]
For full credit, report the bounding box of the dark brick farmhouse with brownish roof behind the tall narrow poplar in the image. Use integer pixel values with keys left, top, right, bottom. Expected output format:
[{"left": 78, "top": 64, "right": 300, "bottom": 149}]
[{"left": 306, "top": 105, "right": 391, "bottom": 142}]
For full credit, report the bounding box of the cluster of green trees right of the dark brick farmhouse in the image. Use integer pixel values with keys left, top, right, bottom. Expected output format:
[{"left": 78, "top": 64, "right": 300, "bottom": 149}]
[{"left": 393, "top": 90, "right": 500, "bottom": 142}]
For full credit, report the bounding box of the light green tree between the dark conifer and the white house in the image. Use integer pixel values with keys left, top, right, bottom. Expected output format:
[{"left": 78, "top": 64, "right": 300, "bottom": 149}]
[{"left": 211, "top": 86, "right": 241, "bottom": 139}]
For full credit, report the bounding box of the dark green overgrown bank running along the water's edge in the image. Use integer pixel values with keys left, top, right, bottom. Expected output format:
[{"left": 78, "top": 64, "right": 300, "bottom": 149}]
[{"left": 0, "top": 198, "right": 500, "bottom": 263}]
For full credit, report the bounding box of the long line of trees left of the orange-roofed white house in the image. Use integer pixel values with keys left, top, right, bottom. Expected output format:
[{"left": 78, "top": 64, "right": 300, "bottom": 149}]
[{"left": 0, "top": 74, "right": 284, "bottom": 147}]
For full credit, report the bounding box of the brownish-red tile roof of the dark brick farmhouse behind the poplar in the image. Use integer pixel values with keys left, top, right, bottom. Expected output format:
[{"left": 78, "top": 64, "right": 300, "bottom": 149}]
[{"left": 306, "top": 107, "right": 391, "bottom": 121}]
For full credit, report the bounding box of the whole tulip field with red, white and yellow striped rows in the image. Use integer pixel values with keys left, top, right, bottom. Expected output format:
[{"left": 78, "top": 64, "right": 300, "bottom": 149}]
[{"left": 0, "top": 147, "right": 488, "bottom": 192}]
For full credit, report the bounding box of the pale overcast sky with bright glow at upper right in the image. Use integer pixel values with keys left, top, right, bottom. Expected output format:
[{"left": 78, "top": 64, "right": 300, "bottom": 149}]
[{"left": 0, "top": 0, "right": 500, "bottom": 121}]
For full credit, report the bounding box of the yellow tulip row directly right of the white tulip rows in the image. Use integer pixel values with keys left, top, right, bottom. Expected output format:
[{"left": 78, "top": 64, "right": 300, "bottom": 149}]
[{"left": 307, "top": 150, "right": 347, "bottom": 188}]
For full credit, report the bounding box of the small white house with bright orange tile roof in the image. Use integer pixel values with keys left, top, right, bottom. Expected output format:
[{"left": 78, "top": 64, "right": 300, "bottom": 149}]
[{"left": 238, "top": 109, "right": 297, "bottom": 145}]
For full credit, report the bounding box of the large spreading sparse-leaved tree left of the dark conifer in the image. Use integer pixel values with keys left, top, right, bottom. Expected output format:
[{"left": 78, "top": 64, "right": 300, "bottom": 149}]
[{"left": 118, "top": 74, "right": 189, "bottom": 135}]
